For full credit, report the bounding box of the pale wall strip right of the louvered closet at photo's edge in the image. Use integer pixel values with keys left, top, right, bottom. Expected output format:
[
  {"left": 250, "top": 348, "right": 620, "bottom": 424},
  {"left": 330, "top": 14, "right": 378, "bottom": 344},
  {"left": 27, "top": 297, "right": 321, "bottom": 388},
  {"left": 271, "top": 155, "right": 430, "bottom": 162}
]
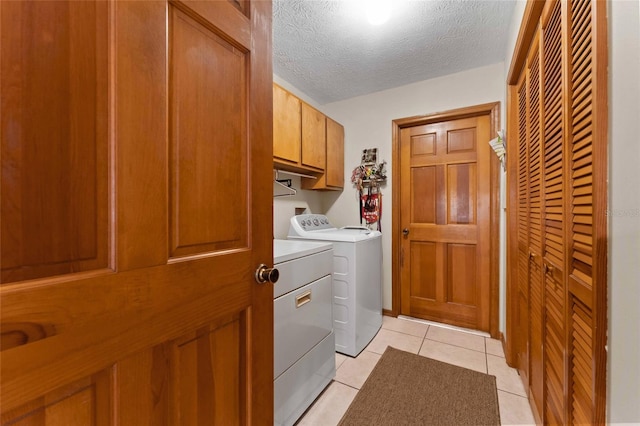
[{"left": 607, "top": 0, "right": 640, "bottom": 424}]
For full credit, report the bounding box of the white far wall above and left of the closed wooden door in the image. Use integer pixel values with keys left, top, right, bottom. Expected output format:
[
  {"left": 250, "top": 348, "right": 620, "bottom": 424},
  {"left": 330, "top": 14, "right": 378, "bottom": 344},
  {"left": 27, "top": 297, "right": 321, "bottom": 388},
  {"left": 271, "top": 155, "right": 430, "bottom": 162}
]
[{"left": 323, "top": 63, "right": 505, "bottom": 309}]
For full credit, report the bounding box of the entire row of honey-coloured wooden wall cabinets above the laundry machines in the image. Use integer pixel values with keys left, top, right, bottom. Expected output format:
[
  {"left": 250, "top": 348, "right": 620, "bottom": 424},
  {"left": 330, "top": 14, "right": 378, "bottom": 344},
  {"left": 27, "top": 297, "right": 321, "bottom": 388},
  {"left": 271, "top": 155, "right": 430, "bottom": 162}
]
[{"left": 273, "top": 84, "right": 344, "bottom": 190}]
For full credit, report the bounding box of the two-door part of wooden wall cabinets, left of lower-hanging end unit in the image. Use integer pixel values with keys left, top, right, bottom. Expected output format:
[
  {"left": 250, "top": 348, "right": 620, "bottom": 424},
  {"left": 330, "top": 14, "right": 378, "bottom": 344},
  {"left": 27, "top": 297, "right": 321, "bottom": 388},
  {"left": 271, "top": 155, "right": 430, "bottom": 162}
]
[{"left": 273, "top": 84, "right": 326, "bottom": 174}]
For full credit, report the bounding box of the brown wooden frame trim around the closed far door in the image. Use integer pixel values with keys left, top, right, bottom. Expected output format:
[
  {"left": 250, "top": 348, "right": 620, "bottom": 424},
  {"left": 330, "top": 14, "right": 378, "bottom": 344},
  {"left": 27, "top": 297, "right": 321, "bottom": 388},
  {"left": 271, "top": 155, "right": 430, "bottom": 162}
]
[{"left": 388, "top": 102, "right": 500, "bottom": 339}]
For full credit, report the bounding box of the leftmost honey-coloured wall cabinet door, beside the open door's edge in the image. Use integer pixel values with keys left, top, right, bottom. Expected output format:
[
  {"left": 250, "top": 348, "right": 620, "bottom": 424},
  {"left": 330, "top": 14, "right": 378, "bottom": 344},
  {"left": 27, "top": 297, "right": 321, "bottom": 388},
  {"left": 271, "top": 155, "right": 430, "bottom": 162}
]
[{"left": 273, "top": 85, "right": 301, "bottom": 164}]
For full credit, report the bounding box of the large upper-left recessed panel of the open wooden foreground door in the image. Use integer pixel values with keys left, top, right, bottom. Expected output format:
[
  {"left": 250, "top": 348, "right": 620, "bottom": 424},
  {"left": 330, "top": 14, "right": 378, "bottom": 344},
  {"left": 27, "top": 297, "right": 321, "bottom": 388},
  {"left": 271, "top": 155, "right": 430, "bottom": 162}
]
[{"left": 0, "top": 2, "right": 110, "bottom": 283}]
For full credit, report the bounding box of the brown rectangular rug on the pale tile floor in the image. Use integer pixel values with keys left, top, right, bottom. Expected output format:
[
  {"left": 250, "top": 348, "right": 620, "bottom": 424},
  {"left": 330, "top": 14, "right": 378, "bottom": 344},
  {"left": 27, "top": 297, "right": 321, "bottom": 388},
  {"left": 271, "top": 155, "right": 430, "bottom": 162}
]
[{"left": 339, "top": 347, "right": 500, "bottom": 426}]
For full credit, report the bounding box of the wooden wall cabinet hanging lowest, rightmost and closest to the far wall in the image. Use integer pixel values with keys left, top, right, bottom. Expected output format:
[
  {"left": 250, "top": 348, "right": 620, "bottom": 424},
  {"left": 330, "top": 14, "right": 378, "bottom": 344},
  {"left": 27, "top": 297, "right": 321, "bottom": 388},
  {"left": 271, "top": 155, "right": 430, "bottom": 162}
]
[{"left": 302, "top": 117, "right": 344, "bottom": 190}]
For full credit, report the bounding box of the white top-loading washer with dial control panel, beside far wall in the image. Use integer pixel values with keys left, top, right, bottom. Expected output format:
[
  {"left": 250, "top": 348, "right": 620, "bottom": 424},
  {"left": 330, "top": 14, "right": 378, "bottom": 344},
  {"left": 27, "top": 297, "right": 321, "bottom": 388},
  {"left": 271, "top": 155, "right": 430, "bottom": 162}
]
[{"left": 287, "top": 214, "right": 382, "bottom": 357}]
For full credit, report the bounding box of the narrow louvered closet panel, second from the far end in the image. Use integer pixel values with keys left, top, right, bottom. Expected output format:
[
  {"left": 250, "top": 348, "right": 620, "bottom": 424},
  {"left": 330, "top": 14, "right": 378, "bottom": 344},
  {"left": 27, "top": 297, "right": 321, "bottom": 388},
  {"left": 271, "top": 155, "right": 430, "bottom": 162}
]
[{"left": 527, "top": 36, "right": 544, "bottom": 420}]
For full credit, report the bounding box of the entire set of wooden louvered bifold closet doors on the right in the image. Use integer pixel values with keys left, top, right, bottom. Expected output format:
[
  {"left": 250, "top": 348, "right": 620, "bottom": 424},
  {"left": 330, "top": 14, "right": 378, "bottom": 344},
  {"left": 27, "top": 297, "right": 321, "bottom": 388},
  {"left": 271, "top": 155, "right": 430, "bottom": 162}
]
[{"left": 507, "top": 0, "right": 607, "bottom": 424}]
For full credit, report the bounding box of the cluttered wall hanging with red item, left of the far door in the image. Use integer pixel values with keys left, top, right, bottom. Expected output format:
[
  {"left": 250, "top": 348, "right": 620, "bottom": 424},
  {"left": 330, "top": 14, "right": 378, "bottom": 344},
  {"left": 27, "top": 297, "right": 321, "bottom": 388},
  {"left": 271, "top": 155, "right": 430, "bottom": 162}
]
[{"left": 351, "top": 148, "right": 387, "bottom": 231}]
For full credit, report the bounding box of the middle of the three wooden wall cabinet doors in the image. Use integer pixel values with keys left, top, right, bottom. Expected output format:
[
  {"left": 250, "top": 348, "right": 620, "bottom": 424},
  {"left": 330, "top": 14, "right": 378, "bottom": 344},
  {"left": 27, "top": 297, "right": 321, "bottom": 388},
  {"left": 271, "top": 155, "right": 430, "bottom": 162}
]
[{"left": 301, "top": 103, "right": 327, "bottom": 170}]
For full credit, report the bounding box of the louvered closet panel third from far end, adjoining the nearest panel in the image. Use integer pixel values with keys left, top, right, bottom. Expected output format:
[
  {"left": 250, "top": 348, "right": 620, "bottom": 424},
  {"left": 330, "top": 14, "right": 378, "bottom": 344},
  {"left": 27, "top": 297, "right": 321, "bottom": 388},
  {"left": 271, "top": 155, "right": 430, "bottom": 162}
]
[{"left": 541, "top": 1, "right": 566, "bottom": 424}]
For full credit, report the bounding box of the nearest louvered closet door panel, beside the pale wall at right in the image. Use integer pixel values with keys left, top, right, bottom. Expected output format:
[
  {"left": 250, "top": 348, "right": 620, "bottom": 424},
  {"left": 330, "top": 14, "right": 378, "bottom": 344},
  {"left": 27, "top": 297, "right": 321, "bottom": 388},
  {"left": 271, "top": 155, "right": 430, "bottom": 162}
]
[{"left": 567, "top": 0, "right": 607, "bottom": 424}]
